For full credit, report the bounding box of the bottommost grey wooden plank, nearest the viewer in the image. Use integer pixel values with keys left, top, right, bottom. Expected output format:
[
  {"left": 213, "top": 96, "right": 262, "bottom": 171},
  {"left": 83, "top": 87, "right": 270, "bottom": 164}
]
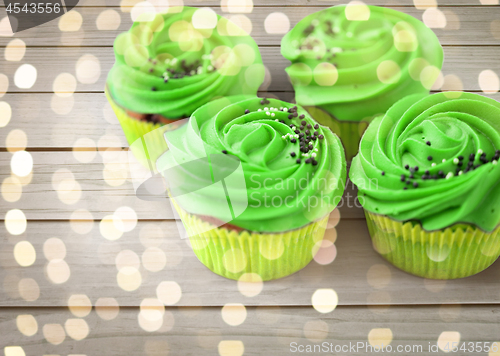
[{"left": 0, "top": 306, "right": 500, "bottom": 356}]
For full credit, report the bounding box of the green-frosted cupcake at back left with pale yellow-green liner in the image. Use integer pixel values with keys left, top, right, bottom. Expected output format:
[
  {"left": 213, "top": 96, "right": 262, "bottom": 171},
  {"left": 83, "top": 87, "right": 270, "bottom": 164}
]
[{"left": 106, "top": 6, "right": 264, "bottom": 165}]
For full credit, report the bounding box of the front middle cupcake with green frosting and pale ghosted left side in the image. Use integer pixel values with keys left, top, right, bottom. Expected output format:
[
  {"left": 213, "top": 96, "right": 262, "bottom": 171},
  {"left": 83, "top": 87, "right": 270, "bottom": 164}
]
[{"left": 157, "top": 98, "right": 346, "bottom": 280}]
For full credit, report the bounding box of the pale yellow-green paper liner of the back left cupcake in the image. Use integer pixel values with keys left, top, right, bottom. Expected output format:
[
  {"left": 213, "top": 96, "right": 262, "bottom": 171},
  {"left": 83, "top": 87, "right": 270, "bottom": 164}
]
[{"left": 105, "top": 88, "right": 176, "bottom": 171}]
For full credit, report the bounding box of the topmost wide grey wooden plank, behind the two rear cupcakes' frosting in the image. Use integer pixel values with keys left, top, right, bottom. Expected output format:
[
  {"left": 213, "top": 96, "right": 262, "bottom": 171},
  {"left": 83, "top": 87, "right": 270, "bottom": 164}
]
[{"left": 0, "top": 2, "right": 500, "bottom": 46}]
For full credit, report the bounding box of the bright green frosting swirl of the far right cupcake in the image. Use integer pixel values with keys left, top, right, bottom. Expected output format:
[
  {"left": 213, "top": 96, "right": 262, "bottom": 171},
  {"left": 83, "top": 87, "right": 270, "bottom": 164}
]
[{"left": 350, "top": 92, "right": 500, "bottom": 232}]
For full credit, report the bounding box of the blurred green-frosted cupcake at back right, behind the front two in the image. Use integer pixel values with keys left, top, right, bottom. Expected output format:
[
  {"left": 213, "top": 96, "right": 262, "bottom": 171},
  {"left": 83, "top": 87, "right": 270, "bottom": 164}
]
[{"left": 281, "top": 4, "right": 443, "bottom": 161}]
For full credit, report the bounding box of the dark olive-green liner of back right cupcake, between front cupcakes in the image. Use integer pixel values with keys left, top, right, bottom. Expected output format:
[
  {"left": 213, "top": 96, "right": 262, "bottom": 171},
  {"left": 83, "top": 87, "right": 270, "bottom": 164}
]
[{"left": 304, "top": 106, "right": 369, "bottom": 162}]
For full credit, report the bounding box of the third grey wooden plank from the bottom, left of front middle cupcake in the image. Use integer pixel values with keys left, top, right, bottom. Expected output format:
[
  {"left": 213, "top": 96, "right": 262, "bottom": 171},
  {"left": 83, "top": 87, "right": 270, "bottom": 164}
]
[{"left": 0, "top": 150, "right": 363, "bottom": 220}]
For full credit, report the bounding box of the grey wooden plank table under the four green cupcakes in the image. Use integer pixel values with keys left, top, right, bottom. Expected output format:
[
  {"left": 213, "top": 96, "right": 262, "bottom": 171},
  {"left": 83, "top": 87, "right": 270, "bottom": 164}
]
[{"left": 0, "top": 0, "right": 500, "bottom": 356}]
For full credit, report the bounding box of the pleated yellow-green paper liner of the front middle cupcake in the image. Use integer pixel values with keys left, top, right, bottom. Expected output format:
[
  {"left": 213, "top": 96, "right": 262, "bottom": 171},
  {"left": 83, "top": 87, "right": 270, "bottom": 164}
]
[{"left": 172, "top": 200, "right": 328, "bottom": 281}]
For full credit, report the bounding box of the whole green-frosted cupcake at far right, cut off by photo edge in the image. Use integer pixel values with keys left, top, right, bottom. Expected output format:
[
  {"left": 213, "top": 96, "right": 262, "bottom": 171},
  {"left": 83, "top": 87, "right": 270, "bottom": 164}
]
[{"left": 349, "top": 92, "right": 500, "bottom": 279}]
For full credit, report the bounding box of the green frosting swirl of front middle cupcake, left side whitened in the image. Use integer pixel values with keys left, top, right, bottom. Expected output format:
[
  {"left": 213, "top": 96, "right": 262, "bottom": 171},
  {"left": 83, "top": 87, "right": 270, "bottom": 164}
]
[{"left": 157, "top": 97, "right": 346, "bottom": 232}]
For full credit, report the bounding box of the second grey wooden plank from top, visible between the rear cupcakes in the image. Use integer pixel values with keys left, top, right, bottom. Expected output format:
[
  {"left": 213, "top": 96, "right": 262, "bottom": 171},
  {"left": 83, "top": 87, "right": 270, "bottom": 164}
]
[{"left": 0, "top": 46, "right": 500, "bottom": 92}]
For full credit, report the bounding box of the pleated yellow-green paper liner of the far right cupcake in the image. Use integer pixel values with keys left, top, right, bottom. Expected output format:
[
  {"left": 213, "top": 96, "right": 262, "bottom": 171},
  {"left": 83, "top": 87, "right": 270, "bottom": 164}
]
[{"left": 365, "top": 210, "right": 500, "bottom": 279}]
